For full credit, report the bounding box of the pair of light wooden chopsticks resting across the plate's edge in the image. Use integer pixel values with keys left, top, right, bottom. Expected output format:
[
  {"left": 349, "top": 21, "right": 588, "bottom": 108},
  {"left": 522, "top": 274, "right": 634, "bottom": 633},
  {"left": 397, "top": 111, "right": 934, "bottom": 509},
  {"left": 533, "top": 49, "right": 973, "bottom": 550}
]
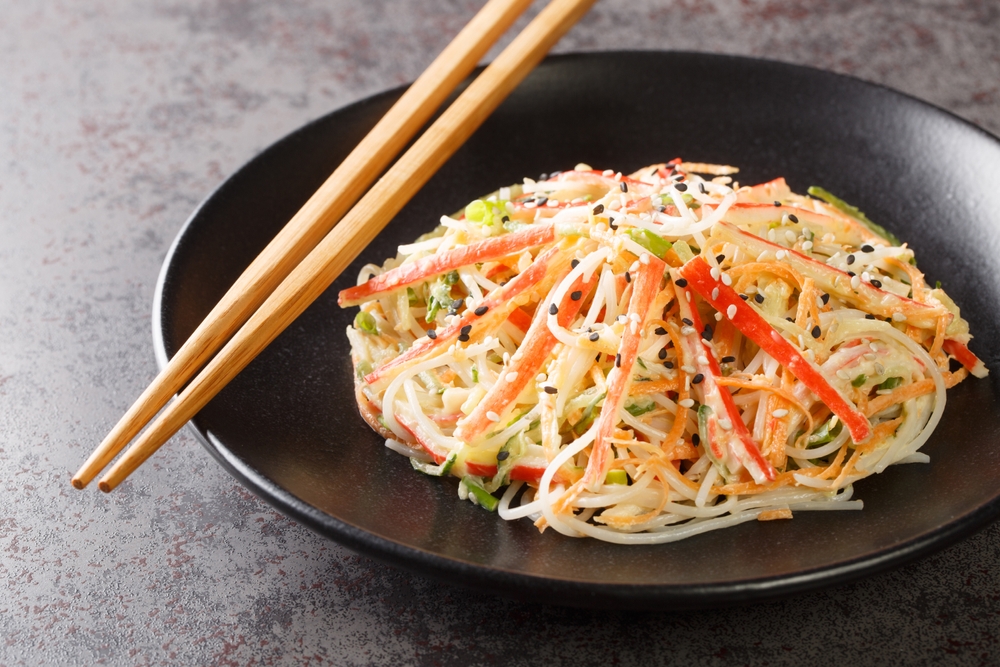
[{"left": 72, "top": 0, "right": 596, "bottom": 492}]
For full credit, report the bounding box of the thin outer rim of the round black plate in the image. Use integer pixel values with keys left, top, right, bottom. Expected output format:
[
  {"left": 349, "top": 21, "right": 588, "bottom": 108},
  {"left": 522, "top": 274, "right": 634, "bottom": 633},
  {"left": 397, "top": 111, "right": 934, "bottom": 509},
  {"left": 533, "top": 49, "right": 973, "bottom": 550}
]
[{"left": 151, "top": 49, "right": 1000, "bottom": 610}]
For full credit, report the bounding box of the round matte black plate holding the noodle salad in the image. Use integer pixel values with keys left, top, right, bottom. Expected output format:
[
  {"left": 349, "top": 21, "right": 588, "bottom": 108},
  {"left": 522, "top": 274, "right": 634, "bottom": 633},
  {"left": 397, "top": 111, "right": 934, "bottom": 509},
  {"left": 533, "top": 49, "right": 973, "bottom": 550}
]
[{"left": 154, "top": 52, "right": 1000, "bottom": 608}]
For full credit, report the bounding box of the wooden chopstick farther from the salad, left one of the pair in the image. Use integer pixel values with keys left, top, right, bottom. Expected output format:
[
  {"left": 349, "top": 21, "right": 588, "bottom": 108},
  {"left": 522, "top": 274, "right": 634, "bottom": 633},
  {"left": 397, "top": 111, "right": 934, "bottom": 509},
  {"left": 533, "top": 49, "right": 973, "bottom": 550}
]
[{"left": 72, "top": 0, "right": 532, "bottom": 489}]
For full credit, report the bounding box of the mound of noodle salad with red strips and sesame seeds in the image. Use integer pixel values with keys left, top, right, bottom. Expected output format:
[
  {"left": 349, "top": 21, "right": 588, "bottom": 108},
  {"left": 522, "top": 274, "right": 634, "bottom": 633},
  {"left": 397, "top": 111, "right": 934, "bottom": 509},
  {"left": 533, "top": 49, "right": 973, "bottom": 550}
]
[{"left": 340, "top": 159, "right": 987, "bottom": 544}]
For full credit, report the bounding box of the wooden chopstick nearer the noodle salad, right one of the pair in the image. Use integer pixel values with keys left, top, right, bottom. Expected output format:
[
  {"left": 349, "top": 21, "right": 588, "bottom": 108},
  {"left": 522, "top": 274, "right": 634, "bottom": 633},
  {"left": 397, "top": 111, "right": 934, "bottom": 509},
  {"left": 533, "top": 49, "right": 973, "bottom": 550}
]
[{"left": 98, "top": 0, "right": 595, "bottom": 492}]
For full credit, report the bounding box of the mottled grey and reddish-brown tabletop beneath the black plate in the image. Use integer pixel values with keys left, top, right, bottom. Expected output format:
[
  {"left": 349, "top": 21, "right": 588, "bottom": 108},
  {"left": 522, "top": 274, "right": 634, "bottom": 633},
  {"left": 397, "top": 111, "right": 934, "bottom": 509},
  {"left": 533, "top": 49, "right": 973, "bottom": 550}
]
[{"left": 0, "top": 0, "right": 1000, "bottom": 665}]
